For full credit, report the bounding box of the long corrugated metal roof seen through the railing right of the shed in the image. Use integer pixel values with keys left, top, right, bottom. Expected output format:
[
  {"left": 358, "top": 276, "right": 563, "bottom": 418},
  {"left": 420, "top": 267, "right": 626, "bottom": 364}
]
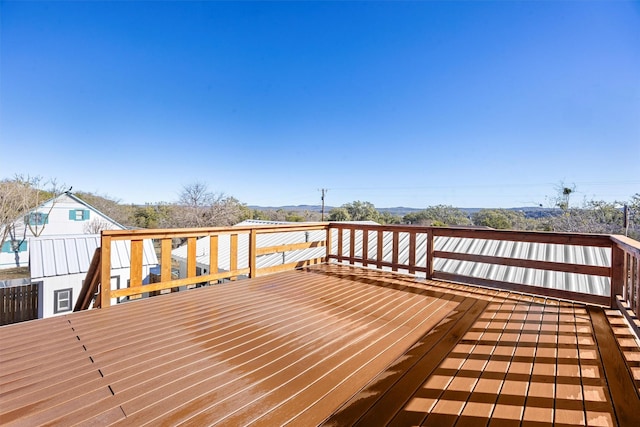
[{"left": 173, "top": 226, "right": 611, "bottom": 296}]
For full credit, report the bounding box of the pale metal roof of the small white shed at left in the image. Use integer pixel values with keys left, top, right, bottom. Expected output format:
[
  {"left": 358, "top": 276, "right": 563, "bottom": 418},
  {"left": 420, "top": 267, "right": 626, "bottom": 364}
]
[{"left": 29, "top": 234, "right": 158, "bottom": 279}]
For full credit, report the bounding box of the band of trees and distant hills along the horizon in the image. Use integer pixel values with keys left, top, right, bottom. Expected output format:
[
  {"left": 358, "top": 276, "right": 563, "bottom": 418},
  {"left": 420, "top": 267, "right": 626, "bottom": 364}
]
[{"left": 0, "top": 177, "right": 640, "bottom": 239}]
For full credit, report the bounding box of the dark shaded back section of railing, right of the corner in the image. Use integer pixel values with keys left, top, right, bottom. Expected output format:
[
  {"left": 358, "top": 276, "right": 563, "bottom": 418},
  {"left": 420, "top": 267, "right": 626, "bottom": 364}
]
[{"left": 329, "top": 223, "right": 613, "bottom": 305}]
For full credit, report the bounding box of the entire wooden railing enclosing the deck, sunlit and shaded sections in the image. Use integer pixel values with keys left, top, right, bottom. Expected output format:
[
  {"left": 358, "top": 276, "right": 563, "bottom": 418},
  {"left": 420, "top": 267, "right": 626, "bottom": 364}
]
[{"left": 91, "top": 223, "right": 640, "bottom": 334}]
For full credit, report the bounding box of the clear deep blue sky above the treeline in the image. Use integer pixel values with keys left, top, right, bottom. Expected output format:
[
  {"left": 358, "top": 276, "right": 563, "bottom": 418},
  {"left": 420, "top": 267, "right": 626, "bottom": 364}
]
[{"left": 0, "top": 1, "right": 640, "bottom": 207}]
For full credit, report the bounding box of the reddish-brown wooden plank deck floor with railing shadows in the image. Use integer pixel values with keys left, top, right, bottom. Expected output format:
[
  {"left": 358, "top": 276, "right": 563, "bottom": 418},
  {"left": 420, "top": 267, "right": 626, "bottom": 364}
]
[{"left": 0, "top": 264, "right": 640, "bottom": 426}]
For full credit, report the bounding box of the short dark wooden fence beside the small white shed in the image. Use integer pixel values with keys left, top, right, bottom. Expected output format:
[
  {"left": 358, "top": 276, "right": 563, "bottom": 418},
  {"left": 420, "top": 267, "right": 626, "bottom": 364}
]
[{"left": 0, "top": 283, "right": 38, "bottom": 325}]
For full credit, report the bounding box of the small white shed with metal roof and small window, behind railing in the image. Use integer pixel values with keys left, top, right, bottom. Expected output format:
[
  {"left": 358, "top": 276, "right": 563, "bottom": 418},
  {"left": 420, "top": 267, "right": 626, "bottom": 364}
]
[{"left": 29, "top": 234, "right": 158, "bottom": 318}]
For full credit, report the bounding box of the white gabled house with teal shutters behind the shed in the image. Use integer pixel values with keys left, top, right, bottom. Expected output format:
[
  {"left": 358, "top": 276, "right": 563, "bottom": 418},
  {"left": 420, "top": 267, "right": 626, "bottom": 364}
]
[{"left": 0, "top": 192, "right": 125, "bottom": 269}]
